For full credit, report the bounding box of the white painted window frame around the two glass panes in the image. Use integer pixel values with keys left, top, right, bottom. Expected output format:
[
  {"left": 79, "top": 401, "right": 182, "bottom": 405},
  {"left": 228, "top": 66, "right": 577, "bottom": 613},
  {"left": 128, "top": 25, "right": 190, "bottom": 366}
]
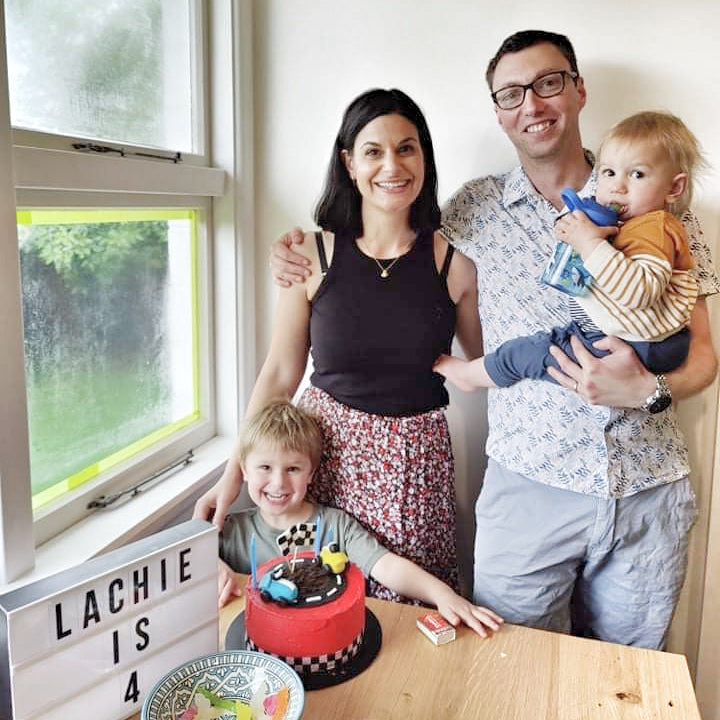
[{"left": 0, "top": 0, "right": 255, "bottom": 585}]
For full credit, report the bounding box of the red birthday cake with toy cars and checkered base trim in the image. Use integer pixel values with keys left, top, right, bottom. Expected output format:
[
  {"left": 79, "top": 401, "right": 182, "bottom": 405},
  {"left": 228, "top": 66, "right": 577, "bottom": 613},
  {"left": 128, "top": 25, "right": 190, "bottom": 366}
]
[{"left": 245, "top": 552, "right": 365, "bottom": 678}]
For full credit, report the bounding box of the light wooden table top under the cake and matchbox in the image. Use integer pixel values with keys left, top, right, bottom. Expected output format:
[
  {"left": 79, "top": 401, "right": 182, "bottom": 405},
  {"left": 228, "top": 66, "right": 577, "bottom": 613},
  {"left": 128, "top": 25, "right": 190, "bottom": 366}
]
[{"left": 135, "top": 598, "right": 700, "bottom": 720}]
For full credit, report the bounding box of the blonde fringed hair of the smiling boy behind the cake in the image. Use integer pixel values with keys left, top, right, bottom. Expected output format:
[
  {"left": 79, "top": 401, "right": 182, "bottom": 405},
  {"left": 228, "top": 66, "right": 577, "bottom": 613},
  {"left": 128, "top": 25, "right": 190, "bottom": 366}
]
[{"left": 237, "top": 401, "right": 323, "bottom": 470}]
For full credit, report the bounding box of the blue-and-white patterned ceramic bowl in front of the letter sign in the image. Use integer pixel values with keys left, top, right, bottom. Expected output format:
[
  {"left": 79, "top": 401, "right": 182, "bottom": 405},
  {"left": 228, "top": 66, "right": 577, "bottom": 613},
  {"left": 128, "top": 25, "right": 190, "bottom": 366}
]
[{"left": 141, "top": 650, "right": 305, "bottom": 720}]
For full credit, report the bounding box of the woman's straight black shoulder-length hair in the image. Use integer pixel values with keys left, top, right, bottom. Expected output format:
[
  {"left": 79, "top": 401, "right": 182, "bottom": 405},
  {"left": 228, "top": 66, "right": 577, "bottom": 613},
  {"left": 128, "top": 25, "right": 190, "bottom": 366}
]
[{"left": 313, "top": 89, "right": 440, "bottom": 237}]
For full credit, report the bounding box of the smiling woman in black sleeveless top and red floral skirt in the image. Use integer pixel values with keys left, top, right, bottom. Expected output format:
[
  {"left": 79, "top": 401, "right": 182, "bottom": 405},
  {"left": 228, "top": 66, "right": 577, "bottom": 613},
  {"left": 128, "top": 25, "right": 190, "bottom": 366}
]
[{"left": 195, "top": 90, "right": 482, "bottom": 599}]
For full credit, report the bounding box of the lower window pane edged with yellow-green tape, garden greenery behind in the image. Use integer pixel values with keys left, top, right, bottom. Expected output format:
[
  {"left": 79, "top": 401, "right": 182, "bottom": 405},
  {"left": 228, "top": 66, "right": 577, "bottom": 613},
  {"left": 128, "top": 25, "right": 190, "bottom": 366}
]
[{"left": 18, "top": 209, "right": 200, "bottom": 509}]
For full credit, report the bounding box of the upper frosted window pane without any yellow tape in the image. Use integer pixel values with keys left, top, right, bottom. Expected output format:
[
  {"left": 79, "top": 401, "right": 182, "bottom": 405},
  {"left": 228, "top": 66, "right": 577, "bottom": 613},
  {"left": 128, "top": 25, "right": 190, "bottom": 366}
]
[{"left": 5, "top": 0, "right": 200, "bottom": 153}]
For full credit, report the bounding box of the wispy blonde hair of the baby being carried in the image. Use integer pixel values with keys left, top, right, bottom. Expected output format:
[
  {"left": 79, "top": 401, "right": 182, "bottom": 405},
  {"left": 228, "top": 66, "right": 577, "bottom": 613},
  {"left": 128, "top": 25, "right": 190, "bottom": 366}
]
[{"left": 598, "top": 110, "right": 705, "bottom": 217}]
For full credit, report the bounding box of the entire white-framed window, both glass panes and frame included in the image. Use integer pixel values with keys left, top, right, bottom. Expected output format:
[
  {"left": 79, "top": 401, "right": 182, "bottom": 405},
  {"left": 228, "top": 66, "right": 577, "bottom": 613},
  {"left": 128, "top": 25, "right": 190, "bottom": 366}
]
[{"left": 0, "top": 0, "right": 254, "bottom": 583}]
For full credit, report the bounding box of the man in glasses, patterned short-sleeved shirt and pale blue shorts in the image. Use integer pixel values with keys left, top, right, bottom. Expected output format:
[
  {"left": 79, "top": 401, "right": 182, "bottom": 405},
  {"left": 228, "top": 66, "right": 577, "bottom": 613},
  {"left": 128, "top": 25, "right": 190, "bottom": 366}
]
[{"left": 274, "top": 31, "right": 720, "bottom": 648}]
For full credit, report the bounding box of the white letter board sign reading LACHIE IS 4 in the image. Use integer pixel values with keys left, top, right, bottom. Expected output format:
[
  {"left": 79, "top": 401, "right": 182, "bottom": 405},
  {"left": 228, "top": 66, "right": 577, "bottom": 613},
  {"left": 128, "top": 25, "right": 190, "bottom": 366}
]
[{"left": 0, "top": 520, "right": 218, "bottom": 720}]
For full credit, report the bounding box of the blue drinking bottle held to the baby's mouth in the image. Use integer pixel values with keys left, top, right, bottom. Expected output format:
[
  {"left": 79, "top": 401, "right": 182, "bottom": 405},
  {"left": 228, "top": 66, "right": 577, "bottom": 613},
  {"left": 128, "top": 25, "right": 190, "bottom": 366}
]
[{"left": 542, "top": 188, "right": 618, "bottom": 296}]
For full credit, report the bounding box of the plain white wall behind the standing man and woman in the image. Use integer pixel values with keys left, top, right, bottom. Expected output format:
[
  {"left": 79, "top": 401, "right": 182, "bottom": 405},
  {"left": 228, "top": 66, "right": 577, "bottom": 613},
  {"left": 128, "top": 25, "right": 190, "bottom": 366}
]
[{"left": 254, "top": 0, "right": 720, "bottom": 708}]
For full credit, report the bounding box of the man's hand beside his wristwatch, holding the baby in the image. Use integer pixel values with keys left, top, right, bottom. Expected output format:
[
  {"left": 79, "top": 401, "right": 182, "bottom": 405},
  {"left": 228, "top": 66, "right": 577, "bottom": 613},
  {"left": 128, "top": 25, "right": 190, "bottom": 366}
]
[{"left": 548, "top": 336, "right": 656, "bottom": 408}]
